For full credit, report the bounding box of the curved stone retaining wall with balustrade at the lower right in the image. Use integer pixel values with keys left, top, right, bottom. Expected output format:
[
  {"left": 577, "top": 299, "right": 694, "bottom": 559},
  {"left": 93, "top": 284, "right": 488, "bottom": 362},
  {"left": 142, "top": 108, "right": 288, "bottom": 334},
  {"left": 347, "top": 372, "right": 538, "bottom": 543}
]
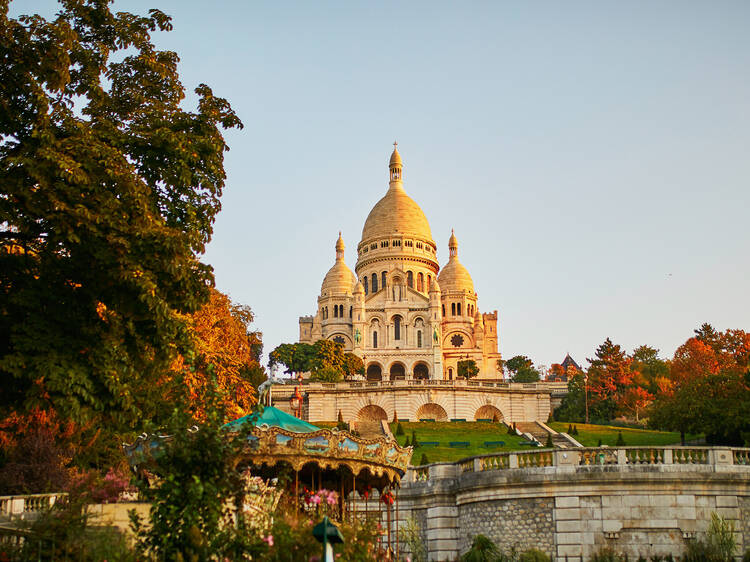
[{"left": 397, "top": 447, "right": 750, "bottom": 562}]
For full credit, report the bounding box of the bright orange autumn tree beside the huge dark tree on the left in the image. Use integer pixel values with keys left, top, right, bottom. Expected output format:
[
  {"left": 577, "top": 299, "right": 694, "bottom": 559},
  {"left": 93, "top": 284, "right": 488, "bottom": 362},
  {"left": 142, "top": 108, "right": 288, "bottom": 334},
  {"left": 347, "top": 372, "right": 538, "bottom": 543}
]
[{"left": 173, "top": 289, "right": 265, "bottom": 420}]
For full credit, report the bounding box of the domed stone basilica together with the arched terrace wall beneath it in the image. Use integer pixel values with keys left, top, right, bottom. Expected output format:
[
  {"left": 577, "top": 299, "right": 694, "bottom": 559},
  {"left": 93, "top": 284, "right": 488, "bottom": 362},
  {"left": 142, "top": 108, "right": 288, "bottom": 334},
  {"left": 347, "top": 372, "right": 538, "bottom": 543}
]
[{"left": 278, "top": 143, "right": 551, "bottom": 423}]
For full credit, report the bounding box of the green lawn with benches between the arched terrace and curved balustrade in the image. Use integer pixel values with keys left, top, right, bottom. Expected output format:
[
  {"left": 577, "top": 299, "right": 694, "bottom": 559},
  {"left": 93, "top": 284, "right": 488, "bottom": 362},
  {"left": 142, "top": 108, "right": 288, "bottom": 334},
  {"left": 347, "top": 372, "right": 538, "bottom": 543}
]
[{"left": 390, "top": 422, "right": 530, "bottom": 466}]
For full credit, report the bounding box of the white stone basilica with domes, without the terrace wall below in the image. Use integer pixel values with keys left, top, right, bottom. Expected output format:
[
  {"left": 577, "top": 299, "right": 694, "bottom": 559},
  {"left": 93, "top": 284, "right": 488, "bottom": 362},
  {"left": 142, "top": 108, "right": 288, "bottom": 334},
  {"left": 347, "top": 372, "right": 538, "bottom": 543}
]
[{"left": 299, "top": 148, "right": 502, "bottom": 380}]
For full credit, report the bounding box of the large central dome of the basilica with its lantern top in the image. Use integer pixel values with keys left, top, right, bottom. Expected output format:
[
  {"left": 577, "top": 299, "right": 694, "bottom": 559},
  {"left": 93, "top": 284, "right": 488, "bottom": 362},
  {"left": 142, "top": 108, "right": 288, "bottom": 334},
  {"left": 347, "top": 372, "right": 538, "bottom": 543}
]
[{"left": 362, "top": 144, "right": 432, "bottom": 241}]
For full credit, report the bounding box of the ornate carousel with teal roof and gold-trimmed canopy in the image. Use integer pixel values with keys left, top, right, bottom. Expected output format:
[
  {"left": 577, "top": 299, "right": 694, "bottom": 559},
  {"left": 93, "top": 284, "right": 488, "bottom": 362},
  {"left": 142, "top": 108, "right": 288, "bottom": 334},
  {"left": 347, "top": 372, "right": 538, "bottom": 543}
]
[{"left": 123, "top": 379, "right": 412, "bottom": 556}]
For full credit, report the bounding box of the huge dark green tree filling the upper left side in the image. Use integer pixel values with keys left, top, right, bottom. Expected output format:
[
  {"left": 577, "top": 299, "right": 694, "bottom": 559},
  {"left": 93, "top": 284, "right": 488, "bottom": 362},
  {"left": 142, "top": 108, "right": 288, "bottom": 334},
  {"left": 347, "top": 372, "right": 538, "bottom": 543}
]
[{"left": 0, "top": 0, "right": 242, "bottom": 427}]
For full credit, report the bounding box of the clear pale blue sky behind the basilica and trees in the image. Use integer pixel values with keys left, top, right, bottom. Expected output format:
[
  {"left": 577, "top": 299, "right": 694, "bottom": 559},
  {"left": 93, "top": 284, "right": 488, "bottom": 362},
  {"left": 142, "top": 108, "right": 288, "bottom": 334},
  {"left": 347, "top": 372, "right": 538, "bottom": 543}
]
[{"left": 11, "top": 0, "right": 750, "bottom": 366}]
